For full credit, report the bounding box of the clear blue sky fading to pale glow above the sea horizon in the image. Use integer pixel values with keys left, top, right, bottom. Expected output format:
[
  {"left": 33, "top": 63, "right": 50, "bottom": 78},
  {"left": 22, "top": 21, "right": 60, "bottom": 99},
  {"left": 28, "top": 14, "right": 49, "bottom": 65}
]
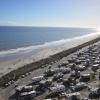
[{"left": 0, "top": 0, "right": 100, "bottom": 28}]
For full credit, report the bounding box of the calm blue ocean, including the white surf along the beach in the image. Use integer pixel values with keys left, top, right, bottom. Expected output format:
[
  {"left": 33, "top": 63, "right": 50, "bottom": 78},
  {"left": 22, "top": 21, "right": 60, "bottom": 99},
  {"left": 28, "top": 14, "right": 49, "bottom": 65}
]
[{"left": 0, "top": 26, "right": 96, "bottom": 60}]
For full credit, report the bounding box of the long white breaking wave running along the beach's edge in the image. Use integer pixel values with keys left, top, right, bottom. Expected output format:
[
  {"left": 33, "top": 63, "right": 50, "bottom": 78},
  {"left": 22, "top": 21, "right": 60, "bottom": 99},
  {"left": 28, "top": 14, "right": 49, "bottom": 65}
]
[{"left": 0, "top": 32, "right": 100, "bottom": 56}]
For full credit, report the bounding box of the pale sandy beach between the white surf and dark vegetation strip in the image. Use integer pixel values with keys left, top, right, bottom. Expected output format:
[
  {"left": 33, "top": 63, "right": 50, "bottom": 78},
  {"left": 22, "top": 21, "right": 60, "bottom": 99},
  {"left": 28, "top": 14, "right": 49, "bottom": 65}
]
[{"left": 0, "top": 32, "right": 100, "bottom": 77}]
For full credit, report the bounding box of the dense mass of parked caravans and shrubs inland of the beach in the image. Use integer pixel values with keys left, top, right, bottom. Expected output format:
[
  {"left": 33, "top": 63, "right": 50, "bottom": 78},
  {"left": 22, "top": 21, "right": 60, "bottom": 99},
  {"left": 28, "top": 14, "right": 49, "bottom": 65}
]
[{"left": 13, "top": 45, "right": 100, "bottom": 100}]
